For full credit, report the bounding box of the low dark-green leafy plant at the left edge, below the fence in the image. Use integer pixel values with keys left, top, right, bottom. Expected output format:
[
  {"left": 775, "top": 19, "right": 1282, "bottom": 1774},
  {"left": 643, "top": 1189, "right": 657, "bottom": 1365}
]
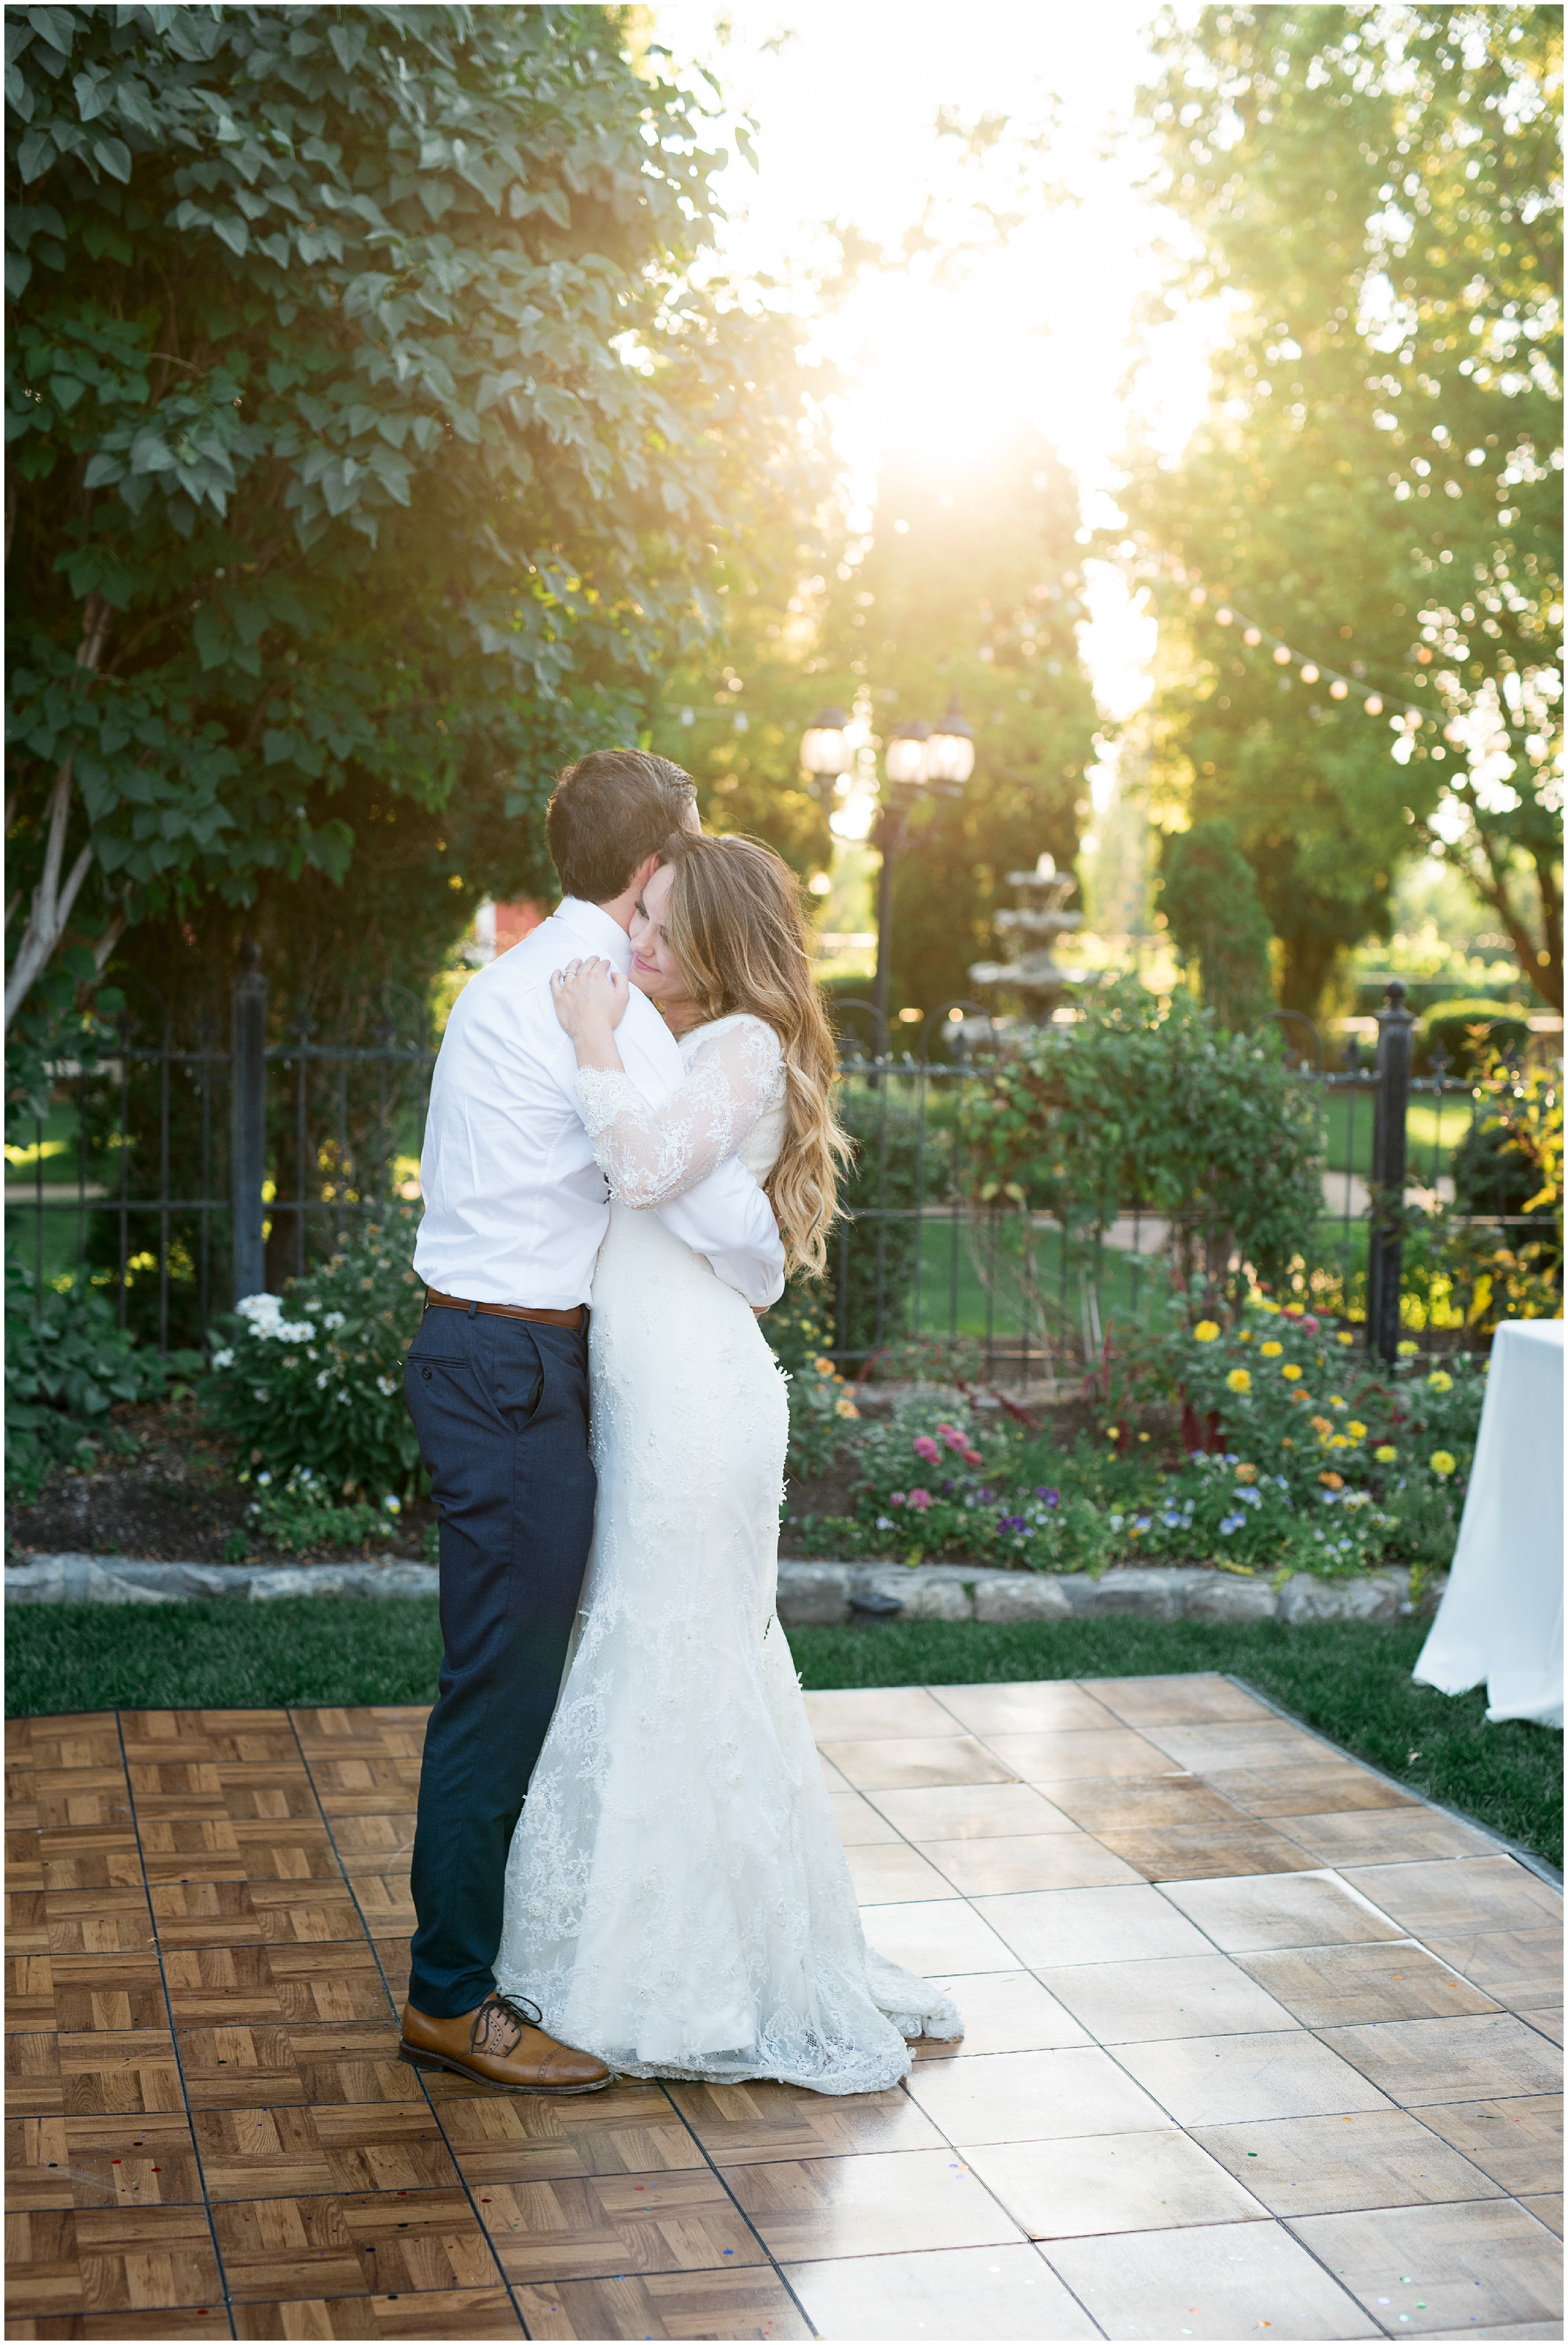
[{"left": 4, "top": 1262, "right": 201, "bottom": 1499}]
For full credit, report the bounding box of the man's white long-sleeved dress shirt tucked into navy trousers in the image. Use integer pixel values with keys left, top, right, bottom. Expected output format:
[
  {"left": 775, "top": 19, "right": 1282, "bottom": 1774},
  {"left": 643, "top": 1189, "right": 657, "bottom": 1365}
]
[{"left": 415, "top": 896, "right": 783, "bottom": 1311}]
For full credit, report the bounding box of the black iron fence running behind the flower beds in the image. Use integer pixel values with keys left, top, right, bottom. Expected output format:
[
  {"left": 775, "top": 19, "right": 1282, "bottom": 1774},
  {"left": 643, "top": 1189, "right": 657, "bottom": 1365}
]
[{"left": 4, "top": 947, "right": 1561, "bottom": 1383}]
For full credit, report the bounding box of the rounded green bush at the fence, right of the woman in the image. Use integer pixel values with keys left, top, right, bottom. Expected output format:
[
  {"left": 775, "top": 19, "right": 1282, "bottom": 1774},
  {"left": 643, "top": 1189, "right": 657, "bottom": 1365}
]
[{"left": 963, "top": 978, "right": 1322, "bottom": 1292}]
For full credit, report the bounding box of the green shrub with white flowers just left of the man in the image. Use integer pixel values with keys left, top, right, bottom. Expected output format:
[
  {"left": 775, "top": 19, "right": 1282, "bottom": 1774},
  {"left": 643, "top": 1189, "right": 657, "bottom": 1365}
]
[{"left": 204, "top": 1208, "right": 422, "bottom": 1499}]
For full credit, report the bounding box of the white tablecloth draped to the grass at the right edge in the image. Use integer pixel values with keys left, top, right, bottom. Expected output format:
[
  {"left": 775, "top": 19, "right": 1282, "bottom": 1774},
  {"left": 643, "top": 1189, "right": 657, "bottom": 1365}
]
[{"left": 1413, "top": 1320, "right": 1564, "bottom": 1726}]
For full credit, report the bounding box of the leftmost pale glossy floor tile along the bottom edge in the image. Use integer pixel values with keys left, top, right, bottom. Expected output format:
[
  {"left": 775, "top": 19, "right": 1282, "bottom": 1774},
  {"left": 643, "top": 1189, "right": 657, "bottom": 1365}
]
[{"left": 785, "top": 2247, "right": 1099, "bottom": 2345}]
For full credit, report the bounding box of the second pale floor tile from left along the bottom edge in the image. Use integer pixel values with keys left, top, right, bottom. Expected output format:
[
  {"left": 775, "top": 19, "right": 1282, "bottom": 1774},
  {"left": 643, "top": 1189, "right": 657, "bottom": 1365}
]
[{"left": 1046, "top": 2223, "right": 1380, "bottom": 2341}]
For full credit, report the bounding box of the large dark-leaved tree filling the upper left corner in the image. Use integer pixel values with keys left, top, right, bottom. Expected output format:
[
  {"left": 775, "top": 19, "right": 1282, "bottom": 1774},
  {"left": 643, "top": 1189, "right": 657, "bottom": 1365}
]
[{"left": 7, "top": 4, "right": 820, "bottom": 1074}]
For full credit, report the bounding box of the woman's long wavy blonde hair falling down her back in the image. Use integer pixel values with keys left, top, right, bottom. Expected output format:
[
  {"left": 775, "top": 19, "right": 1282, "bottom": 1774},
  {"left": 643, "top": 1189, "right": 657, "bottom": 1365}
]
[{"left": 659, "top": 830, "right": 849, "bottom": 1278}]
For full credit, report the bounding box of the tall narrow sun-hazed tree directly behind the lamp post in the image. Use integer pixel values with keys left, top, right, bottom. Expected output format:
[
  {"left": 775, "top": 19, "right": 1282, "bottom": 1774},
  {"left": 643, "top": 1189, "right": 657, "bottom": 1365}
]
[{"left": 802, "top": 429, "right": 1099, "bottom": 1011}]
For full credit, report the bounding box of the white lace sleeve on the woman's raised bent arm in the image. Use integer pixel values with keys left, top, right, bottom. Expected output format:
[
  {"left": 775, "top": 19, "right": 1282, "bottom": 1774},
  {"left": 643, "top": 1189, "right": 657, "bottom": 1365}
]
[{"left": 576, "top": 1018, "right": 785, "bottom": 1208}]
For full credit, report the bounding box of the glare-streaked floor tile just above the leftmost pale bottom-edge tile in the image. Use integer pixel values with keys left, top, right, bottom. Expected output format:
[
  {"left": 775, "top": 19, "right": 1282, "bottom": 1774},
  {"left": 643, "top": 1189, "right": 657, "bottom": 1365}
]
[{"left": 722, "top": 2148, "right": 1022, "bottom": 2263}]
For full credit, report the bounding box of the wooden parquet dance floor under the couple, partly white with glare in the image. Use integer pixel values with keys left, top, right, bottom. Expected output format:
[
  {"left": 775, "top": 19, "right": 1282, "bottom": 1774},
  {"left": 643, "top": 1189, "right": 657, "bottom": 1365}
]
[{"left": 4, "top": 1677, "right": 1561, "bottom": 2341}]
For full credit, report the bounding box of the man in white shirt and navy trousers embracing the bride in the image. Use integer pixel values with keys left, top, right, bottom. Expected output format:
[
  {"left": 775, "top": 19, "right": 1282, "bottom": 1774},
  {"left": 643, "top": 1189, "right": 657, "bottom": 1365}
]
[{"left": 401, "top": 750, "right": 783, "bottom": 2097}]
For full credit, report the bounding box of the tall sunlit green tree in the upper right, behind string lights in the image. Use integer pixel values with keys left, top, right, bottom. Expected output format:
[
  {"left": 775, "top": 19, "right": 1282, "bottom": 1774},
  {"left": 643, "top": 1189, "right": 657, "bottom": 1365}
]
[{"left": 1123, "top": 4, "right": 1561, "bottom": 1008}]
